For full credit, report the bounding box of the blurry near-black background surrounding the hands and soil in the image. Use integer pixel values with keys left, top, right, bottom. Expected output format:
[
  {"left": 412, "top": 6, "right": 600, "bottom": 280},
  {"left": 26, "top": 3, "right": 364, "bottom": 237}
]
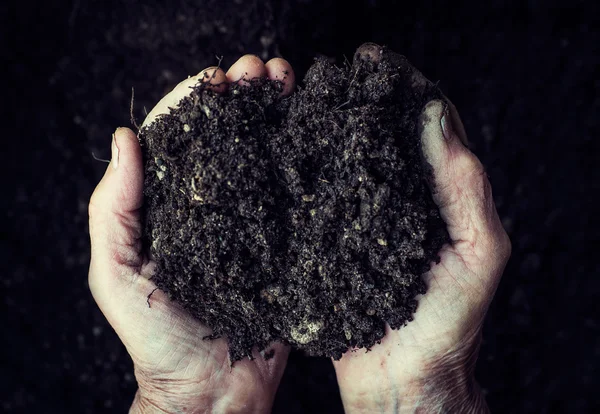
[{"left": 0, "top": 0, "right": 600, "bottom": 413}]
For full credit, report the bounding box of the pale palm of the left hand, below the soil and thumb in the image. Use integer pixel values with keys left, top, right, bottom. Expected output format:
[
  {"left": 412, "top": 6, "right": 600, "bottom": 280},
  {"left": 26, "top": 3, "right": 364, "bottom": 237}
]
[{"left": 94, "top": 256, "right": 288, "bottom": 410}]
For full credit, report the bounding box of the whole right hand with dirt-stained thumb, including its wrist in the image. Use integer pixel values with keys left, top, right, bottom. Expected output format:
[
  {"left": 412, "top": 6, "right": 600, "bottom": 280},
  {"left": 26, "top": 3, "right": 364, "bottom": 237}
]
[{"left": 334, "top": 50, "right": 511, "bottom": 413}]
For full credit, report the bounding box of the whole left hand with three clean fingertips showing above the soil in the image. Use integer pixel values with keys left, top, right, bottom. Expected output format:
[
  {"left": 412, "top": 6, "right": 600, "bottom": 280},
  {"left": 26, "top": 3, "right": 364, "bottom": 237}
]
[{"left": 89, "top": 55, "right": 294, "bottom": 413}]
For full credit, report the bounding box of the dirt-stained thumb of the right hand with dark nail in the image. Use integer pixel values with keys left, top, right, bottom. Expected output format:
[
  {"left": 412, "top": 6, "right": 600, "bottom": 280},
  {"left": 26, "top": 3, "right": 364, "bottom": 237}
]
[{"left": 421, "top": 100, "right": 506, "bottom": 259}]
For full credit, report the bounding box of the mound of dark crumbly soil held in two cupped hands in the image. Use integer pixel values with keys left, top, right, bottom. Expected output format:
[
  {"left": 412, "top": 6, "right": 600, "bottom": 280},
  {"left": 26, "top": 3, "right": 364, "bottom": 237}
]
[{"left": 139, "top": 45, "right": 449, "bottom": 362}]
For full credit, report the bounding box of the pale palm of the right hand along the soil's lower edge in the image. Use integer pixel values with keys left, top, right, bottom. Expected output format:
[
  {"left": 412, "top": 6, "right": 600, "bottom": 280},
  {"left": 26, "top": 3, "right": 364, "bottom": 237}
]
[{"left": 336, "top": 245, "right": 484, "bottom": 379}]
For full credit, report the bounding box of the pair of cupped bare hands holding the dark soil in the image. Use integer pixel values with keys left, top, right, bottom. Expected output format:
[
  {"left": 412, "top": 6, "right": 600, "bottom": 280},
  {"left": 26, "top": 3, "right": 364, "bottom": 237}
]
[{"left": 89, "top": 44, "right": 511, "bottom": 413}]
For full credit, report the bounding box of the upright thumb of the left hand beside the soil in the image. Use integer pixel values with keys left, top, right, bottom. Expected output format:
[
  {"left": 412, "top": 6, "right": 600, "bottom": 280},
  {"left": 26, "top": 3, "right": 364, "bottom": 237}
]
[{"left": 89, "top": 128, "right": 145, "bottom": 296}]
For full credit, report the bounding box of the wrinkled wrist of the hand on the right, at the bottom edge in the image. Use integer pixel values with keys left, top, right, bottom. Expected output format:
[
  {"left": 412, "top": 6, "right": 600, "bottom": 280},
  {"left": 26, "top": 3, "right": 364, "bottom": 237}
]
[{"left": 338, "top": 333, "right": 489, "bottom": 414}]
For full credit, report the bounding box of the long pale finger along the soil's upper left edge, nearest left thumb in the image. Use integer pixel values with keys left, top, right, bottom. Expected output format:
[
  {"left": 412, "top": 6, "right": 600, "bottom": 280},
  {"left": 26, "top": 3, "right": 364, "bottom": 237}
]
[{"left": 142, "top": 66, "right": 227, "bottom": 128}]
